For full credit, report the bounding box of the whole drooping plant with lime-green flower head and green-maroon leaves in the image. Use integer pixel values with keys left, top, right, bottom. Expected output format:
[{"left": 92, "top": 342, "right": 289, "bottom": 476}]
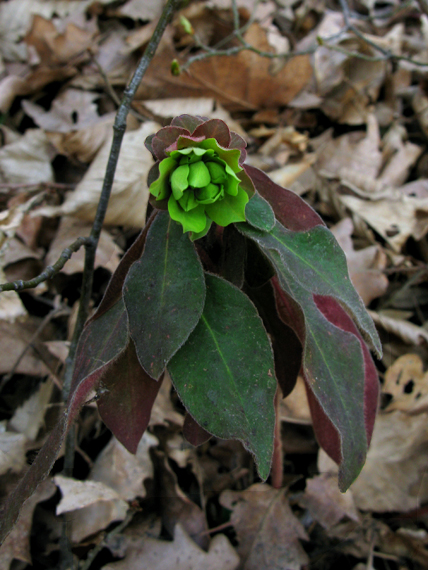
[{"left": 0, "top": 115, "right": 381, "bottom": 544}]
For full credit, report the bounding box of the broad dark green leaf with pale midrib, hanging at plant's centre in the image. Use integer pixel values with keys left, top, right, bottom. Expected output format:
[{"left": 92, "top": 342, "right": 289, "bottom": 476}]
[{"left": 168, "top": 274, "right": 276, "bottom": 480}]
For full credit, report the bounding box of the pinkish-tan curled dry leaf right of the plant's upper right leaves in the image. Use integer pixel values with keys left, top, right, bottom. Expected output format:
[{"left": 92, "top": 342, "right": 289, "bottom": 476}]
[{"left": 331, "top": 218, "right": 389, "bottom": 305}]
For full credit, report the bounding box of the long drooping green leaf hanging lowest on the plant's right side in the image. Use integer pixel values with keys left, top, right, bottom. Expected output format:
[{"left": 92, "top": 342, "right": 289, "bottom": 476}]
[{"left": 274, "top": 275, "right": 367, "bottom": 490}]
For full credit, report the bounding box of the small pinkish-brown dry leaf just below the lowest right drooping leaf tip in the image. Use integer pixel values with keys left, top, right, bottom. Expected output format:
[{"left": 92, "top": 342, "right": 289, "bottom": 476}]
[{"left": 299, "top": 473, "right": 360, "bottom": 530}]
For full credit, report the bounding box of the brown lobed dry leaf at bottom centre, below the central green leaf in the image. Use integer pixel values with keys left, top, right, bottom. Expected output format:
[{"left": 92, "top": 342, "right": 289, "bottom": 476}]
[{"left": 220, "top": 483, "right": 309, "bottom": 570}]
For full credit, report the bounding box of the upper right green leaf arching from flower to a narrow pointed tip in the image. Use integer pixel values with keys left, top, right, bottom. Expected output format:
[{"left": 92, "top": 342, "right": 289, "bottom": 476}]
[{"left": 238, "top": 222, "right": 382, "bottom": 357}]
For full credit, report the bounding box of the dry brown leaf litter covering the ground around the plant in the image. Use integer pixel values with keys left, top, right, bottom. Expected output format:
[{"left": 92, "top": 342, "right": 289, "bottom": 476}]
[{"left": 0, "top": 0, "right": 428, "bottom": 570}]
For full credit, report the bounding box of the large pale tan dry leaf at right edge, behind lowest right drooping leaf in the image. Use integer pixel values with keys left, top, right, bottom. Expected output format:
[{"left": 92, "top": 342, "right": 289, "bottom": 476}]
[{"left": 318, "top": 410, "right": 428, "bottom": 512}]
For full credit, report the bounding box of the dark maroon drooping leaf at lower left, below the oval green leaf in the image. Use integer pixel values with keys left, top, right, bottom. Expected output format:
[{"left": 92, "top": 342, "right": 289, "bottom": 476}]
[{"left": 97, "top": 340, "right": 162, "bottom": 453}]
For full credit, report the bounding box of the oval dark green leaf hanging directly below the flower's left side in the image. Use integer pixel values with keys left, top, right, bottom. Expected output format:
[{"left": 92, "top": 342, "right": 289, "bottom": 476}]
[{"left": 124, "top": 212, "right": 205, "bottom": 379}]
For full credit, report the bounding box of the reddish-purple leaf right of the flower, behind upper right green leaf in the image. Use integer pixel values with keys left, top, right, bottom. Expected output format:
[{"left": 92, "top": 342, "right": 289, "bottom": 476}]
[{"left": 243, "top": 164, "right": 325, "bottom": 231}]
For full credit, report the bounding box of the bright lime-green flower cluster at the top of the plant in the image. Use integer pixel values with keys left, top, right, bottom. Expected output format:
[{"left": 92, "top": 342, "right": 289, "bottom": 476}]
[{"left": 149, "top": 138, "right": 249, "bottom": 240}]
